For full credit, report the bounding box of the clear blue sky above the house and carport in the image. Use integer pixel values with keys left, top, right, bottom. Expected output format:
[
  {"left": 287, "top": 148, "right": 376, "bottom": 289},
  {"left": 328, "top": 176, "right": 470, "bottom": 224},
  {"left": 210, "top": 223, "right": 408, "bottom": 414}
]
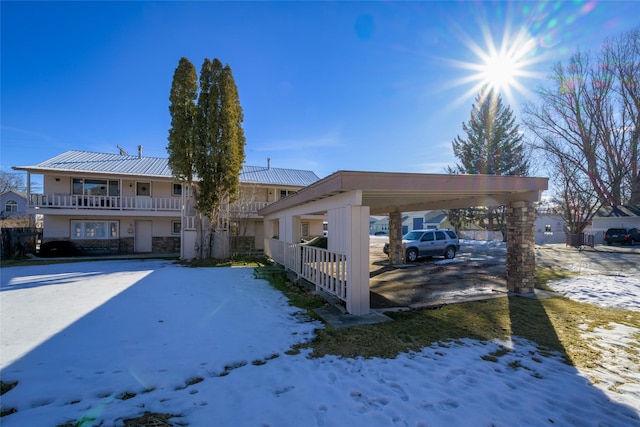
[{"left": 0, "top": 1, "right": 640, "bottom": 181}]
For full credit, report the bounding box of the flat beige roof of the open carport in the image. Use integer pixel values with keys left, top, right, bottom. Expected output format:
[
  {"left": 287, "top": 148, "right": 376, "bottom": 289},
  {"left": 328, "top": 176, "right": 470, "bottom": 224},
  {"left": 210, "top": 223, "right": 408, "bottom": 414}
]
[{"left": 259, "top": 171, "right": 549, "bottom": 216}]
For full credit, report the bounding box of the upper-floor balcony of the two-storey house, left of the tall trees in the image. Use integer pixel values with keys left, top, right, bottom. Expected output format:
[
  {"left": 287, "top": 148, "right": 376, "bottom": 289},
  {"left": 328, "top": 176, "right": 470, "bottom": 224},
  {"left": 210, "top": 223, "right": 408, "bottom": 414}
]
[{"left": 29, "top": 194, "right": 182, "bottom": 216}]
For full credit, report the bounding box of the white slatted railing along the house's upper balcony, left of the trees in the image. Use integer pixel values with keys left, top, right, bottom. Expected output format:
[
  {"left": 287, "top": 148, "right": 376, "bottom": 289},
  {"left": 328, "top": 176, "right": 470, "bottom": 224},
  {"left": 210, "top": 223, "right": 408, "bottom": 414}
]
[{"left": 29, "top": 194, "right": 182, "bottom": 211}]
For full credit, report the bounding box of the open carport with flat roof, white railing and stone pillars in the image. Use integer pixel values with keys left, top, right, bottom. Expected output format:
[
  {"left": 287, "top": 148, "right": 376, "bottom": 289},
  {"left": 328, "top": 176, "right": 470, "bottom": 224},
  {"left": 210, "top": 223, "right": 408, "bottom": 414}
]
[{"left": 259, "top": 171, "right": 548, "bottom": 315}]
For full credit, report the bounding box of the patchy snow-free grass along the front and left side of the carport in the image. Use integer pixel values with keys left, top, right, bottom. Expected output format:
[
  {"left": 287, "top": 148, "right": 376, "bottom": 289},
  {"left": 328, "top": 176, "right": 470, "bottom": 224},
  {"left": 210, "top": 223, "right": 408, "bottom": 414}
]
[{"left": 265, "top": 268, "right": 640, "bottom": 374}]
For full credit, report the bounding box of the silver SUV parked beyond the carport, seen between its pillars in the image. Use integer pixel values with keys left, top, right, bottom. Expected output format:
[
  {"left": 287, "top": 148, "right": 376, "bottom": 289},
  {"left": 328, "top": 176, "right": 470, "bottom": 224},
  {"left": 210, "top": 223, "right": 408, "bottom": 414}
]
[{"left": 383, "top": 229, "right": 460, "bottom": 262}]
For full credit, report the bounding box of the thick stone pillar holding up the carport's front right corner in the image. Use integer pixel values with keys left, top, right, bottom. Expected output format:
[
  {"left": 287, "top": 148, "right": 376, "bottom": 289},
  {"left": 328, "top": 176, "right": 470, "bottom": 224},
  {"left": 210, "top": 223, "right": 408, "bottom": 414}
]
[{"left": 507, "top": 202, "right": 536, "bottom": 294}]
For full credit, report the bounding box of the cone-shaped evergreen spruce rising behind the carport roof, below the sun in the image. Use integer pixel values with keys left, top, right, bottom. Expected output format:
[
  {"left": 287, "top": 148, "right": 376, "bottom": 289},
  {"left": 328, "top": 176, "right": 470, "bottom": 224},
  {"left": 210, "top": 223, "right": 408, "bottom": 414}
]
[{"left": 449, "top": 90, "right": 529, "bottom": 239}]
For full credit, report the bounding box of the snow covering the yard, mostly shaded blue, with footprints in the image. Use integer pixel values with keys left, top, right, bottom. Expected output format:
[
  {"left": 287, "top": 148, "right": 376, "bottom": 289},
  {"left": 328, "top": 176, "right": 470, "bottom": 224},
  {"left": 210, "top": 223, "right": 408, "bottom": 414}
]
[{"left": 0, "top": 260, "right": 640, "bottom": 427}]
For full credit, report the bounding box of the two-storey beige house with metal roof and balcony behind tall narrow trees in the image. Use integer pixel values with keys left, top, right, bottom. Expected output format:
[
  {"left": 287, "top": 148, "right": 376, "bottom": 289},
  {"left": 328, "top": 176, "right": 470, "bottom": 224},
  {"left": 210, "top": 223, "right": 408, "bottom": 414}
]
[{"left": 14, "top": 150, "right": 322, "bottom": 258}]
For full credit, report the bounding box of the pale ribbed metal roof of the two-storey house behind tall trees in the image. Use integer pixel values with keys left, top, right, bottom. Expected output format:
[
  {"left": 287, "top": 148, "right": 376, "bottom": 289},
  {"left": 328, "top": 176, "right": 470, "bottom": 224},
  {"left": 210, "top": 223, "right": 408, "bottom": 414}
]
[{"left": 14, "top": 150, "right": 320, "bottom": 187}]
